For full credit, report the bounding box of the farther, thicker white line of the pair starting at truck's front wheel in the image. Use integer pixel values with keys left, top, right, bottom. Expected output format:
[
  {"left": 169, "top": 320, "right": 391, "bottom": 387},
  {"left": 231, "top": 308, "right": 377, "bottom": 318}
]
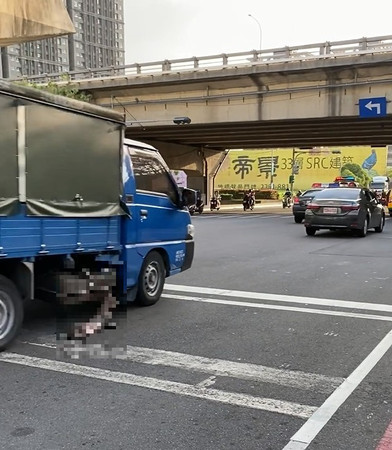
[{"left": 165, "top": 284, "right": 392, "bottom": 312}]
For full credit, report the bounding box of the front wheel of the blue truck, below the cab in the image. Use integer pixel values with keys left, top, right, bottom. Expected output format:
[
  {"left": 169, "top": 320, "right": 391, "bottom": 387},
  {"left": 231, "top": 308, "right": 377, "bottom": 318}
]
[{"left": 136, "top": 251, "right": 166, "bottom": 306}]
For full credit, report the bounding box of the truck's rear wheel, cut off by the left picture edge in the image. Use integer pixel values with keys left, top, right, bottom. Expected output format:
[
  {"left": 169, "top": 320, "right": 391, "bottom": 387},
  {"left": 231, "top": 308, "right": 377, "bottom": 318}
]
[{"left": 0, "top": 275, "right": 24, "bottom": 351}]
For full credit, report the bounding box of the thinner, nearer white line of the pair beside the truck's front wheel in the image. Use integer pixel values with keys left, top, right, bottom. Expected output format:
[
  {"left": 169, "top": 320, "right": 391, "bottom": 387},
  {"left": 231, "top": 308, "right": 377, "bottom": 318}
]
[{"left": 162, "top": 294, "right": 392, "bottom": 322}]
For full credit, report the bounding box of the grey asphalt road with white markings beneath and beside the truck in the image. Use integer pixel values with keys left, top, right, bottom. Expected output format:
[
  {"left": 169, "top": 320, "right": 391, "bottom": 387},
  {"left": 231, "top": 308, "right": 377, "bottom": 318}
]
[{"left": 0, "top": 204, "right": 392, "bottom": 450}]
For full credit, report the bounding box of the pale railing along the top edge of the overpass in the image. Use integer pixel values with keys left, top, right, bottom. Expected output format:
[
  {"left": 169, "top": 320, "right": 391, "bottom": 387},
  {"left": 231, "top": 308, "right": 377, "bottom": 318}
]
[{"left": 11, "top": 35, "right": 392, "bottom": 83}]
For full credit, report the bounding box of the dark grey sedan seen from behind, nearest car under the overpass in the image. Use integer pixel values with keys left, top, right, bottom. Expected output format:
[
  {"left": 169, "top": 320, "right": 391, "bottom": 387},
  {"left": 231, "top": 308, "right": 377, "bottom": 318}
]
[{"left": 304, "top": 187, "right": 385, "bottom": 237}]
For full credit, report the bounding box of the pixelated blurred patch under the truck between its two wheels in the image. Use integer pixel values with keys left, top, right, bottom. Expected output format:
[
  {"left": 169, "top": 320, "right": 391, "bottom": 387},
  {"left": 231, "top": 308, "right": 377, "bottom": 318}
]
[{"left": 57, "top": 268, "right": 118, "bottom": 341}]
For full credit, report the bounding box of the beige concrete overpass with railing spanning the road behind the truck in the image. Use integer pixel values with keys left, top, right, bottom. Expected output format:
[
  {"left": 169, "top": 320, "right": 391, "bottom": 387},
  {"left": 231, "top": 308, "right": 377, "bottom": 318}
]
[{"left": 20, "top": 35, "right": 392, "bottom": 200}]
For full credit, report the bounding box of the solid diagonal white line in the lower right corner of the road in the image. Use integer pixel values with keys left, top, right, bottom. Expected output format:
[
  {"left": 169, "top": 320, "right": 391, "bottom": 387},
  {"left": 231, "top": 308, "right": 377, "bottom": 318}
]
[{"left": 283, "top": 331, "right": 392, "bottom": 450}]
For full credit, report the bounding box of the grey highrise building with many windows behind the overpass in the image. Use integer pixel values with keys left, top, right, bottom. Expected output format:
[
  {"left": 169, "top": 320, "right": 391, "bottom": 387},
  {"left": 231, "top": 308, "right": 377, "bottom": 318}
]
[{"left": 0, "top": 0, "right": 125, "bottom": 79}]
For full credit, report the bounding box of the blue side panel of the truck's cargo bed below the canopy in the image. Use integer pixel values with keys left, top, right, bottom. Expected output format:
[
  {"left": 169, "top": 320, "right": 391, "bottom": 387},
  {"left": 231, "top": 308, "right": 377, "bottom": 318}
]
[{"left": 0, "top": 208, "right": 121, "bottom": 259}]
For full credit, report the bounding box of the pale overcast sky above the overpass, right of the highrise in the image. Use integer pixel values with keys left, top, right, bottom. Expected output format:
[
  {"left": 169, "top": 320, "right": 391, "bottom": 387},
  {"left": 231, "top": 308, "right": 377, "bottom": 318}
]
[{"left": 124, "top": 0, "right": 392, "bottom": 64}]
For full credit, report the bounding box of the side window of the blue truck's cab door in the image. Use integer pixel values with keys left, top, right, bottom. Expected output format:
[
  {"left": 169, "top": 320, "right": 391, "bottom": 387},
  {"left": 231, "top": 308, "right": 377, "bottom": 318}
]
[{"left": 132, "top": 154, "right": 178, "bottom": 204}]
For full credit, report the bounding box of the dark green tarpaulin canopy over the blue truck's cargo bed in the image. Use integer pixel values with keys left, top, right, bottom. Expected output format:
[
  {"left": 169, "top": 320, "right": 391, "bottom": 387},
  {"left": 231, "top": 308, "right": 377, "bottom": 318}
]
[{"left": 0, "top": 81, "right": 125, "bottom": 217}]
